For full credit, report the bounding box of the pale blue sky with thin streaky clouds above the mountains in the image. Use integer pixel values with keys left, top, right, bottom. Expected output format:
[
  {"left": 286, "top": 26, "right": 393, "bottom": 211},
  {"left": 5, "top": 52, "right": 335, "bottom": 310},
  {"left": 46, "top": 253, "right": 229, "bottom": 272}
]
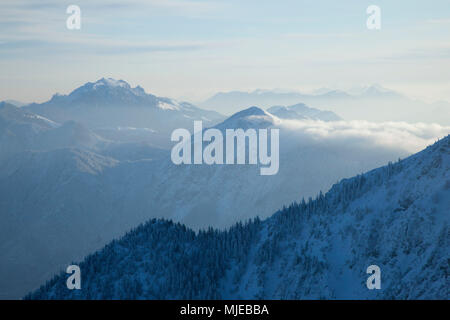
[{"left": 0, "top": 0, "right": 450, "bottom": 101}]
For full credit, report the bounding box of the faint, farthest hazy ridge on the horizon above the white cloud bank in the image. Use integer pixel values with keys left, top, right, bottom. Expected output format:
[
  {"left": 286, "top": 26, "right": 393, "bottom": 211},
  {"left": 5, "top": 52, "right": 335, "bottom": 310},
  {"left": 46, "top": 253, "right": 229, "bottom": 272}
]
[{"left": 200, "top": 85, "right": 450, "bottom": 125}]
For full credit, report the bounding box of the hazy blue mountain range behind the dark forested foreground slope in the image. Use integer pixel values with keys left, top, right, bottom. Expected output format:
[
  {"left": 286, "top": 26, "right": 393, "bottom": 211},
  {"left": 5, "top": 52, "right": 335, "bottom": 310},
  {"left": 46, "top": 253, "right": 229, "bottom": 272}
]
[{"left": 0, "top": 79, "right": 449, "bottom": 298}]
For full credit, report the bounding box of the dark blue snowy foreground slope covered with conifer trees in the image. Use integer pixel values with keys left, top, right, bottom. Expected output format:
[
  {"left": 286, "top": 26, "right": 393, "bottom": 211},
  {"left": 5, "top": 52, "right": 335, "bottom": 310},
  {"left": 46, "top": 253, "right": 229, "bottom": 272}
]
[{"left": 27, "top": 136, "right": 450, "bottom": 299}]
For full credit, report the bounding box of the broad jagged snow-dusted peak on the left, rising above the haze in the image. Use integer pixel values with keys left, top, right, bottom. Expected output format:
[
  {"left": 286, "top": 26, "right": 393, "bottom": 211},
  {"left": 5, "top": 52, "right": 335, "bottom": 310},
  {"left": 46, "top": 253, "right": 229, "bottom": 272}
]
[{"left": 29, "top": 78, "right": 223, "bottom": 127}]
